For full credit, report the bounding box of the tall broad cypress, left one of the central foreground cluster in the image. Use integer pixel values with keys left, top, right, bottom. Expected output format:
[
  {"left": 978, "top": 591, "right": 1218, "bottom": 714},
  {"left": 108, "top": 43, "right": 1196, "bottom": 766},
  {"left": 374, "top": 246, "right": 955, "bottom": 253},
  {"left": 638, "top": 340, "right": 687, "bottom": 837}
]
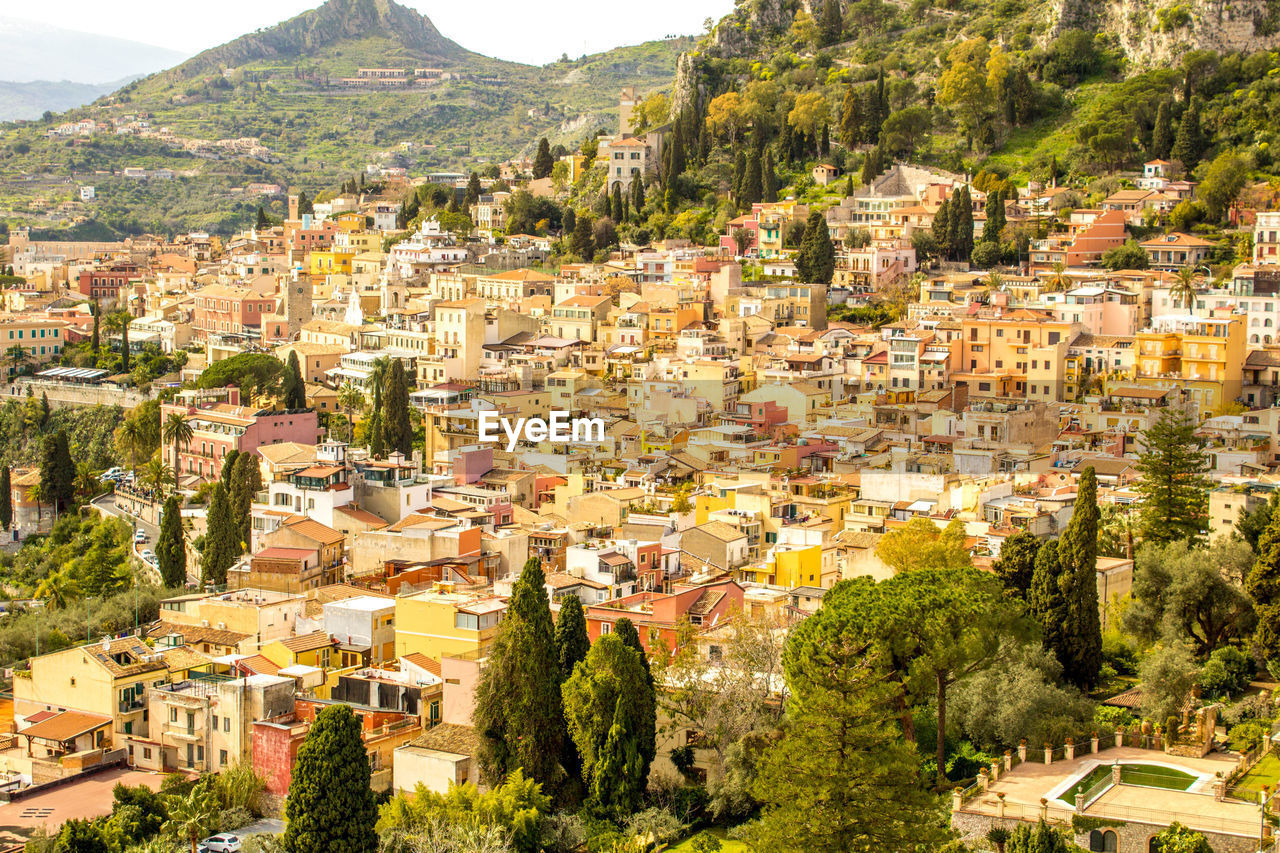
[{"left": 472, "top": 557, "right": 564, "bottom": 786}]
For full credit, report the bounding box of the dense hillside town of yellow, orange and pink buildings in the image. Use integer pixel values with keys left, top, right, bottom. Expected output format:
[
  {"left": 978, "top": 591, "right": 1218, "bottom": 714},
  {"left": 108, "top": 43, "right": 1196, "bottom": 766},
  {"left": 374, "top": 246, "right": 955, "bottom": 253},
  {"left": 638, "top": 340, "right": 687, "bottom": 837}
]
[{"left": 0, "top": 76, "right": 1280, "bottom": 853}]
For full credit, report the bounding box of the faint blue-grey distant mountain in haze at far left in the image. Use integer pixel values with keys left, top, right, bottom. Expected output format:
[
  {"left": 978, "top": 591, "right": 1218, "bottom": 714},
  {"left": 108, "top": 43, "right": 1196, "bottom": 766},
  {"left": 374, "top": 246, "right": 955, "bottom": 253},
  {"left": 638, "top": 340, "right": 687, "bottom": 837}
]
[{"left": 0, "top": 17, "right": 187, "bottom": 83}]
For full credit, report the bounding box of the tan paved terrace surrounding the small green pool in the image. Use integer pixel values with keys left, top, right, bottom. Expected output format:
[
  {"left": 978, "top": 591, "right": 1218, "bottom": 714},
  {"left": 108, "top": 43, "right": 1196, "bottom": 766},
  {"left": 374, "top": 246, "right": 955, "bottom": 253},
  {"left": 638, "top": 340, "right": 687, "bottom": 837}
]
[{"left": 961, "top": 747, "right": 1261, "bottom": 835}]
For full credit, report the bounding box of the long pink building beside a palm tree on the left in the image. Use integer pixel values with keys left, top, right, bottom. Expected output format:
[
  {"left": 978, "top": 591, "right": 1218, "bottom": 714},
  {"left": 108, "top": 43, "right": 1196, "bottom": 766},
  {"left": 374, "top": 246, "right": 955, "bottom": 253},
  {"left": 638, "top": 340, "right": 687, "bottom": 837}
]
[{"left": 160, "top": 388, "right": 324, "bottom": 483}]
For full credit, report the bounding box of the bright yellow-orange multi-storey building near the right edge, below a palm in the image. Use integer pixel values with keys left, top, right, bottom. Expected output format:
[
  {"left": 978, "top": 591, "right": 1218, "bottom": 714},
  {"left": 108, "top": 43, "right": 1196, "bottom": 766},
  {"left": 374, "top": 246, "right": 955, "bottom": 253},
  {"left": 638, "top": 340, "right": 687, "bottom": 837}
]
[{"left": 1134, "top": 315, "right": 1245, "bottom": 415}]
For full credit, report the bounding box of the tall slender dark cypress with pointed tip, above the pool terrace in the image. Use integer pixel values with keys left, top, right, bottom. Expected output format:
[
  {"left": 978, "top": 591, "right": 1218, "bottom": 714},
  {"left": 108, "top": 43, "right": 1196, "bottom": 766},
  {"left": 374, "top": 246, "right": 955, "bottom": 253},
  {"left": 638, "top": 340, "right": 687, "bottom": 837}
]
[{"left": 1057, "top": 465, "right": 1102, "bottom": 689}]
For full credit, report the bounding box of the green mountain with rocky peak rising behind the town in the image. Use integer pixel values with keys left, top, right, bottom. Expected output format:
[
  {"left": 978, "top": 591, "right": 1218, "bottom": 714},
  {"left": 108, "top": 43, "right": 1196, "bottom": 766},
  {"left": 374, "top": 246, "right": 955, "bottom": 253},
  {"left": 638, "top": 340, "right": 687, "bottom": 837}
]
[{"left": 0, "top": 0, "right": 694, "bottom": 234}]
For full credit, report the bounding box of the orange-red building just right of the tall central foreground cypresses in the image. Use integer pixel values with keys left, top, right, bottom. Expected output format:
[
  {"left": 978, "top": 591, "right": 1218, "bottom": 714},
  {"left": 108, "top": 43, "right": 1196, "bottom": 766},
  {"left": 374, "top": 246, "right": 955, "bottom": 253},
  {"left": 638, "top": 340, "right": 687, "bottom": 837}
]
[{"left": 586, "top": 580, "right": 742, "bottom": 652}]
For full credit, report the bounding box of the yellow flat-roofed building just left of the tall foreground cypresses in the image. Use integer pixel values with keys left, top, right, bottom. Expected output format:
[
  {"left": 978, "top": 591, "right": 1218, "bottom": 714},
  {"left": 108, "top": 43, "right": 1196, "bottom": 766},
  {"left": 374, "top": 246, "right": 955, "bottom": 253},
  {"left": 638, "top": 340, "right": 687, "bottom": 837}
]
[{"left": 396, "top": 589, "right": 507, "bottom": 661}]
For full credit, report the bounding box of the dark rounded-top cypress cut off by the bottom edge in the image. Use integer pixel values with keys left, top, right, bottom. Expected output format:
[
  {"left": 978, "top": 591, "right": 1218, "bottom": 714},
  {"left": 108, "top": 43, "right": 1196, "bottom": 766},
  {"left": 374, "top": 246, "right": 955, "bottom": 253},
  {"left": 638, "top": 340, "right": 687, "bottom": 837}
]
[{"left": 283, "top": 703, "right": 378, "bottom": 853}]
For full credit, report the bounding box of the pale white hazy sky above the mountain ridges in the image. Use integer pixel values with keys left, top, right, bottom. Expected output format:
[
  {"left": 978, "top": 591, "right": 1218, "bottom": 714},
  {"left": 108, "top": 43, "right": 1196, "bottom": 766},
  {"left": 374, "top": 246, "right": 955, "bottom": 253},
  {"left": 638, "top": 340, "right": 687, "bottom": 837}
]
[{"left": 5, "top": 0, "right": 733, "bottom": 64}]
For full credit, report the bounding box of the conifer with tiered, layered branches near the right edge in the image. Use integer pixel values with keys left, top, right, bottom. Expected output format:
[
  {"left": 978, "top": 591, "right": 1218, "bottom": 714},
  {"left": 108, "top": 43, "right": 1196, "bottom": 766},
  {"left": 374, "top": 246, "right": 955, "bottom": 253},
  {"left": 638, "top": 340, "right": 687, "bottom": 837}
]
[{"left": 1134, "top": 407, "right": 1211, "bottom": 543}]
